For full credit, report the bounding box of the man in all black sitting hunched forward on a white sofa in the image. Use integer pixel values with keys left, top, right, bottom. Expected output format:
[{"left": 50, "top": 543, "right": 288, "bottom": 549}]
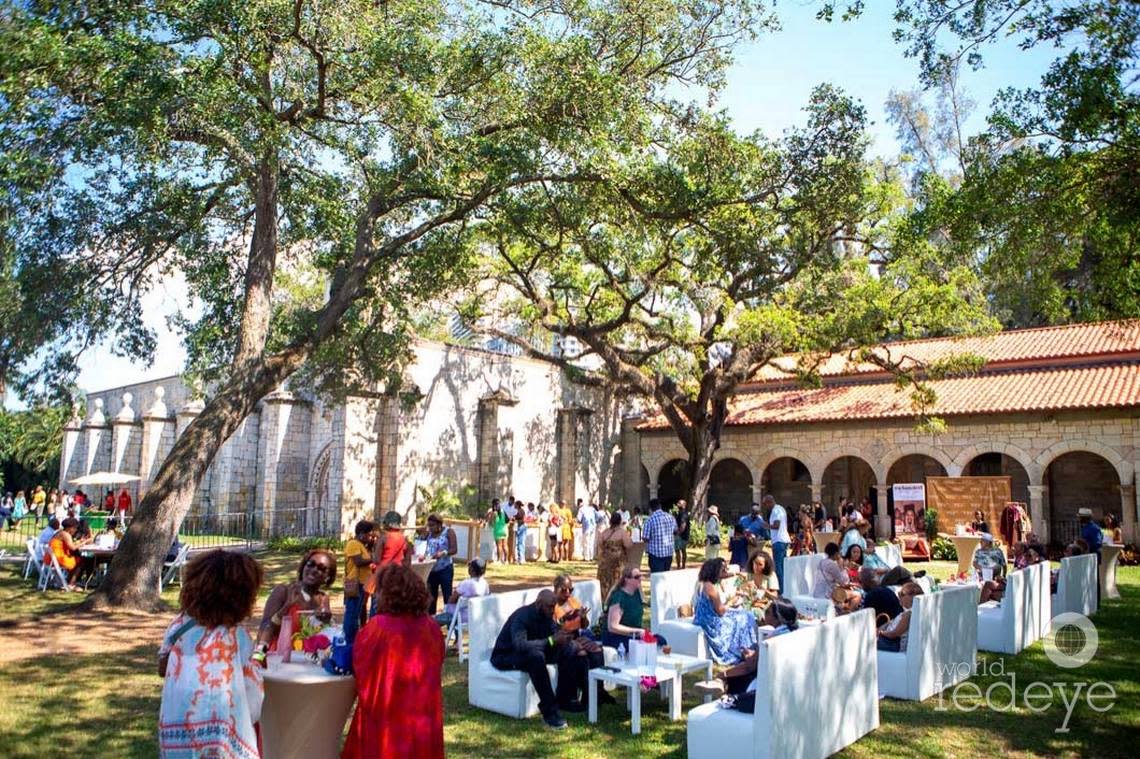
[{"left": 491, "top": 590, "right": 588, "bottom": 729}]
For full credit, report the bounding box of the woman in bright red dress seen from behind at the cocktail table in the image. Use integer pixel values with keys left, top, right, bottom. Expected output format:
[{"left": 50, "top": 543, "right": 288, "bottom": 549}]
[{"left": 341, "top": 564, "right": 443, "bottom": 759}]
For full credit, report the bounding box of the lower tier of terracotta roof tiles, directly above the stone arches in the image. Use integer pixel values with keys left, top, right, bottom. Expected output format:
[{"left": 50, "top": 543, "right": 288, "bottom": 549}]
[{"left": 640, "top": 362, "right": 1140, "bottom": 430}]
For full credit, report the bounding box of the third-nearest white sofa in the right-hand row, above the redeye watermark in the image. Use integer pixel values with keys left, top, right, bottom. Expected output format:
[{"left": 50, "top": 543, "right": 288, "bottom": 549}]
[{"left": 978, "top": 564, "right": 1052, "bottom": 654}]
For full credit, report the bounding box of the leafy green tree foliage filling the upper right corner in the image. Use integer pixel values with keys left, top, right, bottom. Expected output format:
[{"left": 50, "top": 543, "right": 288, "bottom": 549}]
[{"left": 875, "top": 0, "right": 1140, "bottom": 326}]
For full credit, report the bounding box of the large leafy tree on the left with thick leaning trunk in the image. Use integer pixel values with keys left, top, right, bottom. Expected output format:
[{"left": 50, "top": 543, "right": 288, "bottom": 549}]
[{"left": 0, "top": 0, "right": 763, "bottom": 606}]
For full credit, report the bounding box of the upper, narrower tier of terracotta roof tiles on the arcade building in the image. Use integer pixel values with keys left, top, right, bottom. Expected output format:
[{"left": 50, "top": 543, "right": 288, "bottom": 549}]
[{"left": 758, "top": 319, "right": 1140, "bottom": 384}]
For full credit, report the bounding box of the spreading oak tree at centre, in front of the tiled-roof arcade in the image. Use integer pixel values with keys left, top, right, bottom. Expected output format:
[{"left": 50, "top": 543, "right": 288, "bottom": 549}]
[{"left": 466, "top": 87, "right": 992, "bottom": 507}]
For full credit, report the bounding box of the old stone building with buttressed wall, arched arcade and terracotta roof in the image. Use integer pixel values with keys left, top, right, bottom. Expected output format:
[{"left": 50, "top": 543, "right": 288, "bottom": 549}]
[{"left": 60, "top": 320, "right": 1140, "bottom": 540}]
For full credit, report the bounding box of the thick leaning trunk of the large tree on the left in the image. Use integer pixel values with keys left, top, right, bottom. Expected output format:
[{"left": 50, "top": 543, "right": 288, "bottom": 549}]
[{"left": 83, "top": 349, "right": 309, "bottom": 610}]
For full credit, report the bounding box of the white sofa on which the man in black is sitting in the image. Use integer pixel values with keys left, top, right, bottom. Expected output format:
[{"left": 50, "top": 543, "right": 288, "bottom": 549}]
[{"left": 467, "top": 580, "right": 602, "bottom": 719}]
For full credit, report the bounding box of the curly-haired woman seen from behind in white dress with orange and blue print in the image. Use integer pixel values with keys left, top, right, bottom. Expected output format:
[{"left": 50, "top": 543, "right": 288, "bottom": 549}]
[{"left": 158, "top": 550, "right": 262, "bottom": 759}]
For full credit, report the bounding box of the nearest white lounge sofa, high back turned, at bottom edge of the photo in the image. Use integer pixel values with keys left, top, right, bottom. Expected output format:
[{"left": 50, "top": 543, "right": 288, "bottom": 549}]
[{"left": 687, "top": 610, "right": 879, "bottom": 759}]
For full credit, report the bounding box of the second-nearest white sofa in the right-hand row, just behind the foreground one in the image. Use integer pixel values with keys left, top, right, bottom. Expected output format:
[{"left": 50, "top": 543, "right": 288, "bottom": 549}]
[{"left": 877, "top": 586, "right": 978, "bottom": 701}]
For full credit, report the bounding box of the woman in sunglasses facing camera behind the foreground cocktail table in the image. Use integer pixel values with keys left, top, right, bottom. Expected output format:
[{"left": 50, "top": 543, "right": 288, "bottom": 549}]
[{"left": 257, "top": 548, "right": 337, "bottom": 651}]
